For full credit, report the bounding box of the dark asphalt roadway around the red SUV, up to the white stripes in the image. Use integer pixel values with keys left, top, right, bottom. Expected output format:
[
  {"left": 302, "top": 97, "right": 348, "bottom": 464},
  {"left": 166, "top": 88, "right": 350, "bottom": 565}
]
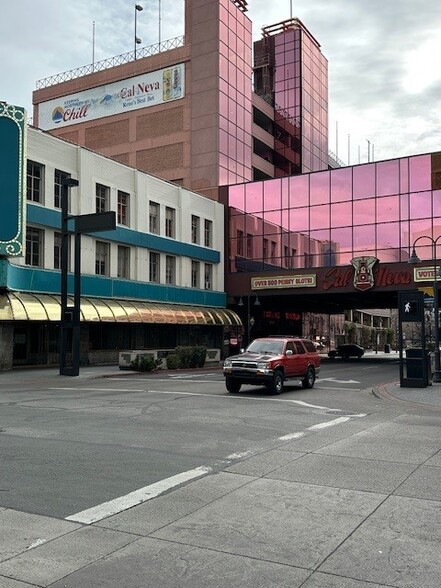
[{"left": 0, "top": 360, "right": 398, "bottom": 518}]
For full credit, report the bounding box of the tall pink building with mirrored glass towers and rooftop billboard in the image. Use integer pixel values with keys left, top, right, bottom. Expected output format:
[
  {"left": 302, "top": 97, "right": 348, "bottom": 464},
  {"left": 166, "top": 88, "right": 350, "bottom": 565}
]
[{"left": 33, "top": 0, "right": 328, "bottom": 199}]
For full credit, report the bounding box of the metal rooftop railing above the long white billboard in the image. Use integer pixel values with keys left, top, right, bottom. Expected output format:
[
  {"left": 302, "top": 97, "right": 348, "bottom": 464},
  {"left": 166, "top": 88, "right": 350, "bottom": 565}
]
[{"left": 36, "top": 35, "right": 185, "bottom": 90}]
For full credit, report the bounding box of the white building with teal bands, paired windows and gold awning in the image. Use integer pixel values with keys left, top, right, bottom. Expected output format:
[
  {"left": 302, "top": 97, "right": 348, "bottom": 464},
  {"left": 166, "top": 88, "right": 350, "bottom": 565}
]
[{"left": 0, "top": 127, "right": 241, "bottom": 369}]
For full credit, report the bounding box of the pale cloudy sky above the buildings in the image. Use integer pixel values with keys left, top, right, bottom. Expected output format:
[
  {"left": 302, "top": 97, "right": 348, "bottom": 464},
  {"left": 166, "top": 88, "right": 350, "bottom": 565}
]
[{"left": 0, "top": 0, "right": 441, "bottom": 165}]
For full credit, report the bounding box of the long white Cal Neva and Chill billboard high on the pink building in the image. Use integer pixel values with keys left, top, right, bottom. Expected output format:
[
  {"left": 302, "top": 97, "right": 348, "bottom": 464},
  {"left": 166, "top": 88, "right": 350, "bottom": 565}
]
[{"left": 38, "top": 63, "right": 185, "bottom": 131}]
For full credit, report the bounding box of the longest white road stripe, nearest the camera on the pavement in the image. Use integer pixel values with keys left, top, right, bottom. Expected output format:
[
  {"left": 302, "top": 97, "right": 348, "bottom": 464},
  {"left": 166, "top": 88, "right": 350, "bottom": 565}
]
[{"left": 65, "top": 466, "right": 212, "bottom": 525}]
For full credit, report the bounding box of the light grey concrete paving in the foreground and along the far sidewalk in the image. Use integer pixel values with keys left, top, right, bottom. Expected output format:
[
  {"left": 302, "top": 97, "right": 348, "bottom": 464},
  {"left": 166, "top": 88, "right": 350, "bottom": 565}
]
[{"left": 0, "top": 366, "right": 441, "bottom": 588}]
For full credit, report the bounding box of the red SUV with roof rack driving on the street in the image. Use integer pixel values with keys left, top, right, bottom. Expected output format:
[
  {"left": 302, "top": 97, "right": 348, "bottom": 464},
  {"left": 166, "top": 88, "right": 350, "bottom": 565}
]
[{"left": 223, "top": 336, "right": 320, "bottom": 394}]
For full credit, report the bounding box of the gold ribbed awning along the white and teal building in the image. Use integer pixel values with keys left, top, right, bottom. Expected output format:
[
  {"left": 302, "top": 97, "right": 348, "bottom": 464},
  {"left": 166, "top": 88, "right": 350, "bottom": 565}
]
[{"left": 0, "top": 292, "right": 242, "bottom": 326}]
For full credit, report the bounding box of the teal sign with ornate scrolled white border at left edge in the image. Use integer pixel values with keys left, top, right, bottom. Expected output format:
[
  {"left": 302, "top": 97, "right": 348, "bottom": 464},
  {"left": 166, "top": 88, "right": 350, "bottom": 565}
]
[{"left": 0, "top": 102, "right": 27, "bottom": 257}]
